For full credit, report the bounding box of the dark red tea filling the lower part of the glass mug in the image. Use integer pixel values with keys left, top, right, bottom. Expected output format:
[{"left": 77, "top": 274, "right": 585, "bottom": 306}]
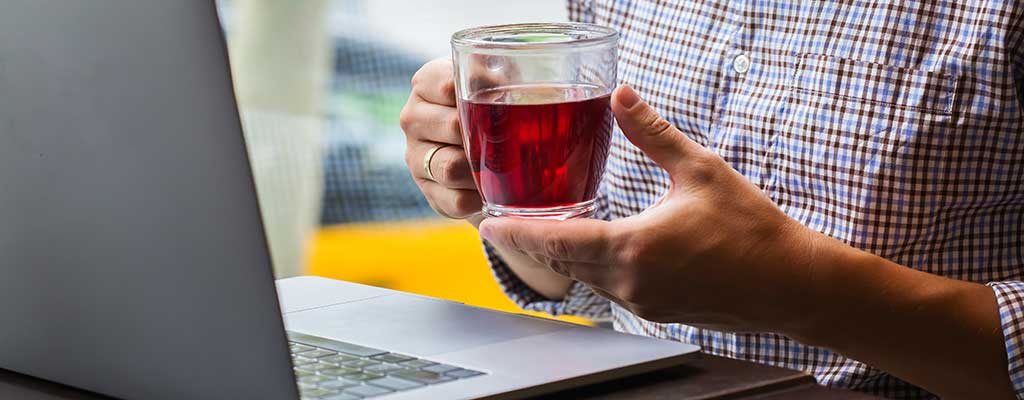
[{"left": 460, "top": 84, "right": 612, "bottom": 217}]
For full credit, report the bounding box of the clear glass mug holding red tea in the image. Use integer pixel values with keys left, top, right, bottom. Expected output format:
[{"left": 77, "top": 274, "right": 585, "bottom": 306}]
[{"left": 452, "top": 24, "right": 618, "bottom": 219}]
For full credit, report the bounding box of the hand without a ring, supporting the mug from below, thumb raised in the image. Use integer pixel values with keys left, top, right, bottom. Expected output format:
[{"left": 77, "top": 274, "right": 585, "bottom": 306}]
[{"left": 480, "top": 86, "right": 813, "bottom": 330}]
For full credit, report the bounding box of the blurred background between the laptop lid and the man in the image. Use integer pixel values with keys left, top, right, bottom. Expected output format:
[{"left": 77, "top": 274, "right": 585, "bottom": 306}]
[{"left": 218, "top": 0, "right": 586, "bottom": 323}]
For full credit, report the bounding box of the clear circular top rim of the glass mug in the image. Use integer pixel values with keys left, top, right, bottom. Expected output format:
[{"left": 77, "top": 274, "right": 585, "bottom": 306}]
[{"left": 452, "top": 23, "right": 618, "bottom": 49}]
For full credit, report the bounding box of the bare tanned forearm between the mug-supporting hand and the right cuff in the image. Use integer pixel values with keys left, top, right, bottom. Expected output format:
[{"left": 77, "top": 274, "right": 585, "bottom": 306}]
[{"left": 787, "top": 233, "right": 1014, "bottom": 399}]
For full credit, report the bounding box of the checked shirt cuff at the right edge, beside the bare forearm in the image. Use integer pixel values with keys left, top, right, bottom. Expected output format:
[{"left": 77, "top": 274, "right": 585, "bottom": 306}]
[{"left": 988, "top": 280, "right": 1024, "bottom": 399}]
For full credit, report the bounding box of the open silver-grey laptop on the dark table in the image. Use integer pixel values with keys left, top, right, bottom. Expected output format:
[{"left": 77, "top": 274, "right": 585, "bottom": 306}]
[{"left": 0, "top": 0, "right": 698, "bottom": 399}]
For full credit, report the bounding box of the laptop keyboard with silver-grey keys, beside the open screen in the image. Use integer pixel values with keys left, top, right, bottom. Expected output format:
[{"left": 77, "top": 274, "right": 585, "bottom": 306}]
[{"left": 288, "top": 331, "right": 484, "bottom": 400}]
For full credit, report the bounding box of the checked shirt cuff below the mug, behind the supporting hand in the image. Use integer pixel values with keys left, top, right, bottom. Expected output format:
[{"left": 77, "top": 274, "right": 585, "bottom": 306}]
[{"left": 483, "top": 241, "right": 611, "bottom": 319}]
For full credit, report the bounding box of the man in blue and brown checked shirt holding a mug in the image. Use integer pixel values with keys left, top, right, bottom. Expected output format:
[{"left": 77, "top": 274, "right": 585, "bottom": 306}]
[{"left": 402, "top": 0, "right": 1024, "bottom": 398}]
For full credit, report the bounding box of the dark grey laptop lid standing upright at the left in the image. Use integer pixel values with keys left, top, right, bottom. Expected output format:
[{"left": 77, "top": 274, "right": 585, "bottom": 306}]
[{"left": 0, "top": 0, "right": 297, "bottom": 399}]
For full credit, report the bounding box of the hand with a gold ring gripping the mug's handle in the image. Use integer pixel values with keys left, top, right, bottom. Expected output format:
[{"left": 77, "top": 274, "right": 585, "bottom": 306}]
[{"left": 400, "top": 58, "right": 483, "bottom": 218}]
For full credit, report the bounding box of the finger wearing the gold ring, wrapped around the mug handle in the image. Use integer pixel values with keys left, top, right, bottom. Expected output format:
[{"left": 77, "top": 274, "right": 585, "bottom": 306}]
[{"left": 406, "top": 142, "right": 476, "bottom": 190}]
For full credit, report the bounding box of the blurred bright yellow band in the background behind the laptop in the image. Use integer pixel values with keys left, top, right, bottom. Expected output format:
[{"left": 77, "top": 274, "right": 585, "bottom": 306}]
[{"left": 306, "top": 219, "right": 590, "bottom": 324}]
